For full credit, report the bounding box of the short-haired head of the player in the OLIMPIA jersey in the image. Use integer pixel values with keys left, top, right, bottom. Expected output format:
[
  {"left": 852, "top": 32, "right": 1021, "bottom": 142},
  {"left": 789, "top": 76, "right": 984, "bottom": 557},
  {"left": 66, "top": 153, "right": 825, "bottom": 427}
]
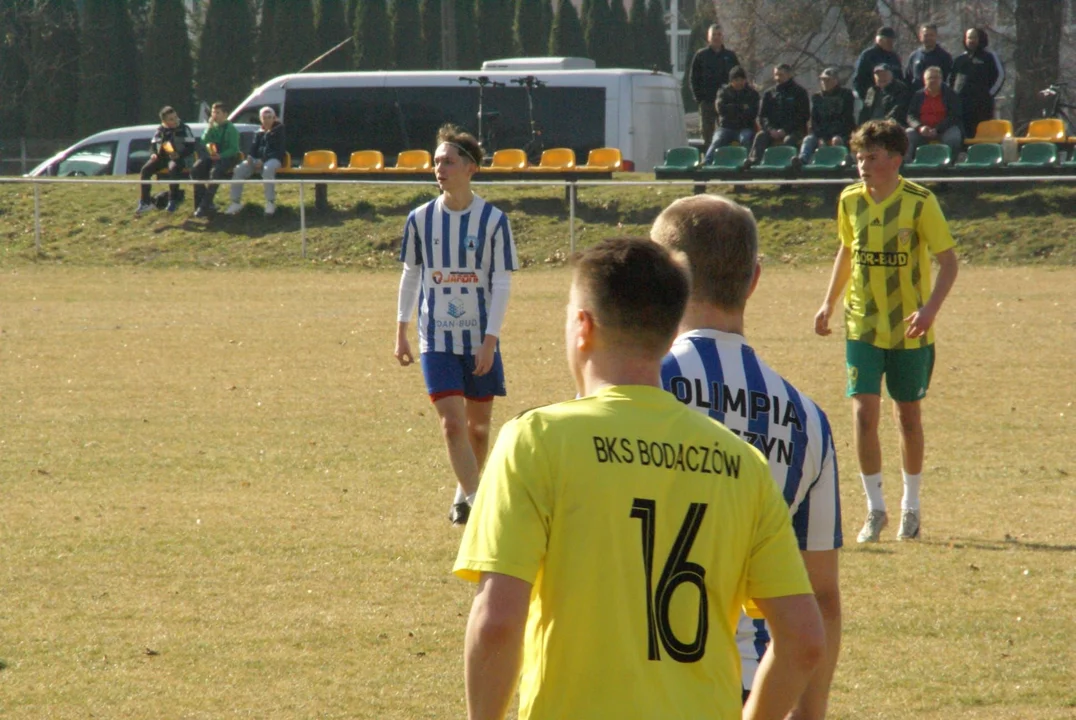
[{"left": 650, "top": 195, "right": 759, "bottom": 310}]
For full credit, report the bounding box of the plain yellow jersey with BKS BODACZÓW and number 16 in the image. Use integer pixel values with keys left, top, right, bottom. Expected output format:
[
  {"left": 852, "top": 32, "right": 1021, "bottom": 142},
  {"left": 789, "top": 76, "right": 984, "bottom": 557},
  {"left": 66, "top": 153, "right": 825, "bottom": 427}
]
[{"left": 454, "top": 385, "right": 811, "bottom": 720}]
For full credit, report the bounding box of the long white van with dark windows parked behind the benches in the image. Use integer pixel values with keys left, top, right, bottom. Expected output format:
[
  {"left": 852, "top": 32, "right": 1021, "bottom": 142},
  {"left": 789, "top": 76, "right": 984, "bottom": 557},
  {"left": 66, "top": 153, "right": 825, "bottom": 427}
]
[{"left": 231, "top": 61, "right": 688, "bottom": 170}]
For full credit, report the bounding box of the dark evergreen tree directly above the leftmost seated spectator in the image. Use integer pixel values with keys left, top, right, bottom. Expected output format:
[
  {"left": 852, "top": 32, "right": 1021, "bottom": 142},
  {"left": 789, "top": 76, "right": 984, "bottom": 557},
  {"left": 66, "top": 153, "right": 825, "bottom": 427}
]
[{"left": 139, "top": 0, "right": 195, "bottom": 123}]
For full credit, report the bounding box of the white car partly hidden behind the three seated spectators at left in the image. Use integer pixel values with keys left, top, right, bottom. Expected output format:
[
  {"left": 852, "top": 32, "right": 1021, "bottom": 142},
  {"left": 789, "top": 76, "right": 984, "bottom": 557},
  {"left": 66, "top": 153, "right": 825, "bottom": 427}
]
[{"left": 26, "top": 123, "right": 258, "bottom": 178}]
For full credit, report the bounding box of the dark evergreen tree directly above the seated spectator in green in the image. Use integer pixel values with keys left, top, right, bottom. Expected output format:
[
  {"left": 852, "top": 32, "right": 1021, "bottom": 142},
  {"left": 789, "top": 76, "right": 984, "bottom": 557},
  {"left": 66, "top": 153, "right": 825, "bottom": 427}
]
[{"left": 196, "top": 0, "right": 254, "bottom": 112}]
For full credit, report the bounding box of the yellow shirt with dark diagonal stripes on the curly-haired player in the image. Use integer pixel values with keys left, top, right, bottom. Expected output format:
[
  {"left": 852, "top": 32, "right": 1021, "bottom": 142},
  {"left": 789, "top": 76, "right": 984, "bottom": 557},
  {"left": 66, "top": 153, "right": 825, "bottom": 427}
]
[{"left": 837, "top": 178, "right": 955, "bottom": 350}]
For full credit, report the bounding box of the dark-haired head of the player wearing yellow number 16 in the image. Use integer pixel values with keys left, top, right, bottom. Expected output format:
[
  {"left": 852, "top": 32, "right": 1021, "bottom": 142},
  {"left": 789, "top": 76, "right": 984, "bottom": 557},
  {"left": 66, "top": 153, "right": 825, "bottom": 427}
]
[{"left": 572, "top": 238, "right": 691, "bottom": 359}]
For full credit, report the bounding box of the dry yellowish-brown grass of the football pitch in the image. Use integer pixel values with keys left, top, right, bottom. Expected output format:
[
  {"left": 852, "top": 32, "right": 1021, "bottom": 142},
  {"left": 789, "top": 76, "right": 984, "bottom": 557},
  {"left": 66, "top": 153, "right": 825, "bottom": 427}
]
[{"left": 0, "top": 261, "right": 1076, "bottom": 720}]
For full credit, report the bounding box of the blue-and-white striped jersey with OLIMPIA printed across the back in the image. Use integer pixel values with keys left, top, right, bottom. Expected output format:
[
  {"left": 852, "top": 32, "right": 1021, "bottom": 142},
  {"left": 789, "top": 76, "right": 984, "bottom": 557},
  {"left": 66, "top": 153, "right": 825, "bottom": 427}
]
[{"left": 662, "top": 329, "right": 844, "bottom": 689}]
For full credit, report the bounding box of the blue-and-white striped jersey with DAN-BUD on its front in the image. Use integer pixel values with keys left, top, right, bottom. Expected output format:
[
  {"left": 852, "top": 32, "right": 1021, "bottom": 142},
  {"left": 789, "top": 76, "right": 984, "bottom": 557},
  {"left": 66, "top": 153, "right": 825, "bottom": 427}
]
[{"left": 399, "top": 195, "right": 519, "bottom": 355}]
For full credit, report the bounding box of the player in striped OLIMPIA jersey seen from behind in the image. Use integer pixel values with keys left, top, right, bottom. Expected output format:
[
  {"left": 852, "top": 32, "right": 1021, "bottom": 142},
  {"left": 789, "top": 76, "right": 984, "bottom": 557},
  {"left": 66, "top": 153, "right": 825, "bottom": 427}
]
[{"left": 650, "top": 193, "right": 851, "bottom": 720}]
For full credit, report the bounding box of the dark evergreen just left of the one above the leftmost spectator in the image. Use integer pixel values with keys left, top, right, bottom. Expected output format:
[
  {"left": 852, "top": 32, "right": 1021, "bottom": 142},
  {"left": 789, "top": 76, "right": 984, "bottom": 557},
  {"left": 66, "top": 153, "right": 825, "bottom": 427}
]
[{"left": 76, "top": 0, "right": 139, "bottom": 135}]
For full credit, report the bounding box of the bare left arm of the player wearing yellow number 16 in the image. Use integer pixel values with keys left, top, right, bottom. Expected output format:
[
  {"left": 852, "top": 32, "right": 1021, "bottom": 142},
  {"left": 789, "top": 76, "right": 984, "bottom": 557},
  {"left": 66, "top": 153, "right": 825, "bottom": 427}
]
[{"left": 464, "top": 573, "right": 530, "bottom": 720}]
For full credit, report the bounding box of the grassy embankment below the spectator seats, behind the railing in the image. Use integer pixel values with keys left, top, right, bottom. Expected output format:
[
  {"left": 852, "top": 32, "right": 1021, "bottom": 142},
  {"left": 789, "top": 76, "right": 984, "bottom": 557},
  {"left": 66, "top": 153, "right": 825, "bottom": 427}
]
[{"left": 0, "top": 174, "right": 1076, "bottom": 268}]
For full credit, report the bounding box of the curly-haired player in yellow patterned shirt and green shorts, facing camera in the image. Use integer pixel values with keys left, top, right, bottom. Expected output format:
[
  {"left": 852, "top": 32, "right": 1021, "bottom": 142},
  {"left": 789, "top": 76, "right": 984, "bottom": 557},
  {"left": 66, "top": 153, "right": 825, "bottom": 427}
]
[{"left": 815, "top": 121, "right": 958, "bottom": 542}]
